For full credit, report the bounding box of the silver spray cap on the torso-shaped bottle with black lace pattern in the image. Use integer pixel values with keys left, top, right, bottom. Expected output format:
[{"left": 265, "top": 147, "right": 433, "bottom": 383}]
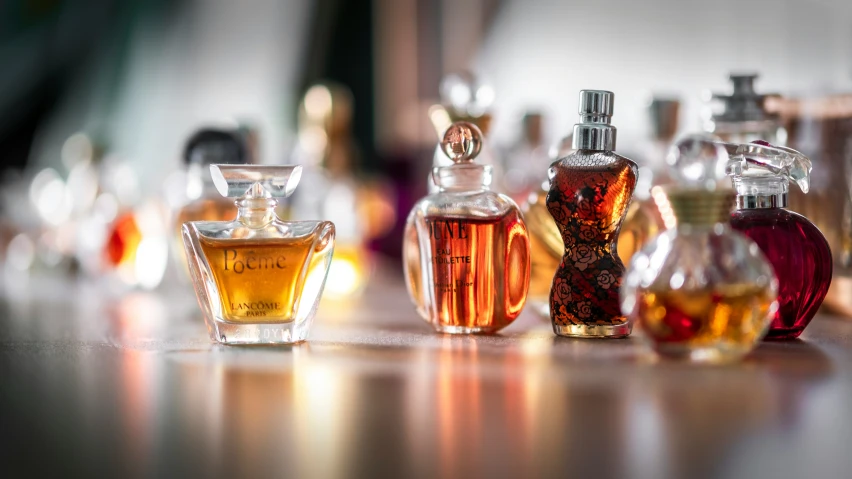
[{"left": 572, "top": 90, "right": 615, "bottom": 151}]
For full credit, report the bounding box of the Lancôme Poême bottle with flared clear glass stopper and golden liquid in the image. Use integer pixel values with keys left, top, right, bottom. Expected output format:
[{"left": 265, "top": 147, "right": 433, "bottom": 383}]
[{"left": 183, "top": 165, "right": 334, "bottom": 344}]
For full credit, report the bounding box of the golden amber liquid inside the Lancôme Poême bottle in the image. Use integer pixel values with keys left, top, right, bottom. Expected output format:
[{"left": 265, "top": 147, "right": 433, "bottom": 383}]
[{"left": 199, "top": 236, "right": 317, "bottom": 323}]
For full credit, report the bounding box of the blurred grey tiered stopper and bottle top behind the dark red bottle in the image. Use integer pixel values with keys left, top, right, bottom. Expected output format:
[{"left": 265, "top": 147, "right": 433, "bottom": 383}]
[{"left": 704, "top": 74, "right": 787, "bottom": 145}]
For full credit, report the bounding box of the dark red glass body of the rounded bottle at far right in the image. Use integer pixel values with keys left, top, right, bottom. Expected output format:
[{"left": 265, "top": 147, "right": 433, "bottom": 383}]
[{"left": 731, "top": 208, "right": 832, "bottom": 339}]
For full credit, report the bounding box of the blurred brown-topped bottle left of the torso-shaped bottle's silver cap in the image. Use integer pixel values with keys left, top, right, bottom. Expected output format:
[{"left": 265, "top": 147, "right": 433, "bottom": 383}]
[{"left": 502, "top": 112, "right": 553, "bottom": 203}]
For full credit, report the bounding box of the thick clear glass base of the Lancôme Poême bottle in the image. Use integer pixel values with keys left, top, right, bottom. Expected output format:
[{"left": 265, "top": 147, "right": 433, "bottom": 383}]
[{"left": 208, "top": 321, "right": 311, "bottom": 345}]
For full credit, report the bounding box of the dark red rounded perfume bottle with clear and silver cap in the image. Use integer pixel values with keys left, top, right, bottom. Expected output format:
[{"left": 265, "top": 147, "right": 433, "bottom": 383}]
[{"left": 727, "top": 142, "right": 833, "bottom": 339}]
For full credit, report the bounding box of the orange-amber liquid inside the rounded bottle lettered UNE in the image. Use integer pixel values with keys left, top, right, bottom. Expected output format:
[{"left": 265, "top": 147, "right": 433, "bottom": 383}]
[{"left": 407, "top": 210, "right": 530, "bottom": 332}]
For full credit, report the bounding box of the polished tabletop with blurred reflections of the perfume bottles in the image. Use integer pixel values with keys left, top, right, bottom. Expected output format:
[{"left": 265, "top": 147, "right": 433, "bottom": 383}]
[{"left": 0, "top": 269, "right": 852, "bottom": 479}]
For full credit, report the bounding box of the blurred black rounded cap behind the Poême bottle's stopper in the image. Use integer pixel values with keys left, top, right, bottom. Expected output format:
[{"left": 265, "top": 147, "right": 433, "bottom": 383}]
[{"left": 183, "top": 128, "right": 249, "bottom": 165}]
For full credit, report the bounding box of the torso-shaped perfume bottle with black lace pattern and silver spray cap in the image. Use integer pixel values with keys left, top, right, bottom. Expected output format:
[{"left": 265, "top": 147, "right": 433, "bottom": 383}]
[{"left": 547, "top": 90, "right": 637, "bottom": 338}]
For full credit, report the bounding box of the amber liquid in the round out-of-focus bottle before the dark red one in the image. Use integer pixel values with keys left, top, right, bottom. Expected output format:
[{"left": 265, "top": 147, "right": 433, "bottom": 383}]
[{"left": 637, "top": 284, "right": 775, "bottom": 361}]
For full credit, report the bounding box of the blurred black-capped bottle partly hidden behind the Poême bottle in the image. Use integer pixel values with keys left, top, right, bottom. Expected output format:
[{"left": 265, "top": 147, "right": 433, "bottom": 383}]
[{"left": 172, "top": 128, "right": 250, "bottom": 278}]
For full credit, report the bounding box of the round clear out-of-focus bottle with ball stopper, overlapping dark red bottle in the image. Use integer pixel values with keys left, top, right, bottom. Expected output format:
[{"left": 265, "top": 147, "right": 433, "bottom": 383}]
[{"left": 621, "top": 135, "right": 778, "bottom": 363}]
